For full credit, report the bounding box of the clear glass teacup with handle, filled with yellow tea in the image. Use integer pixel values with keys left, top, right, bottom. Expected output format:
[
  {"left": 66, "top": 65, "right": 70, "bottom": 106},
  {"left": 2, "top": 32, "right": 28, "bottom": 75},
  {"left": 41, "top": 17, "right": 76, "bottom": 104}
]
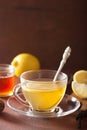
[{"left": 14, "top": 70, "right": 68, "bottom": 113}]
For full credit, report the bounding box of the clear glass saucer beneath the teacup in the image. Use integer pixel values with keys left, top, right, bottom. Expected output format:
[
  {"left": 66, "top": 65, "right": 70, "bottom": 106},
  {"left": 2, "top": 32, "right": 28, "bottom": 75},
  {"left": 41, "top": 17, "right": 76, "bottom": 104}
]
[{"left": 7, "top": 93, "right": 80, "bottom": 118}]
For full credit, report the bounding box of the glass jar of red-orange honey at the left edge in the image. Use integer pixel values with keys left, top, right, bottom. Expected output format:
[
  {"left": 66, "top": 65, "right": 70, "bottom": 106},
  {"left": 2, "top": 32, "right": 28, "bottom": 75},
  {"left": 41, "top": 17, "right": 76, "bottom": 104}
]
[{"left": 0, "top": 64, "right": 15, "bottom": 97}]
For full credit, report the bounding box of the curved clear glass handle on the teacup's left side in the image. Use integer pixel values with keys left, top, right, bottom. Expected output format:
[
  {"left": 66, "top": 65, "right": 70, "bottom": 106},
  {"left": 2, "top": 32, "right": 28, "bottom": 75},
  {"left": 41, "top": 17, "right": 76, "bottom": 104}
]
[{"left": 13, "top": 83, "right": 29, "bottom": 106}]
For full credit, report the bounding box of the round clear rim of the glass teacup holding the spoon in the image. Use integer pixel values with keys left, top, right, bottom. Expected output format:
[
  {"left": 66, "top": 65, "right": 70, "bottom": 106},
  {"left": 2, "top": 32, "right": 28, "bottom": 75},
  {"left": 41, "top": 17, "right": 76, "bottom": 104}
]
[{"left": 20, "top": 69, "right": 68, "bottom": 84}]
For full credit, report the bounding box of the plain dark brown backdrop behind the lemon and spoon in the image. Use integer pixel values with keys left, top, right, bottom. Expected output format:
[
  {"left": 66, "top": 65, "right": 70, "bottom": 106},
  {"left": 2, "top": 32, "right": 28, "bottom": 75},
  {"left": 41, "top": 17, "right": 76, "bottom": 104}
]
[{"left": 0, "top": 0, "right": 87, "bottom": 70}]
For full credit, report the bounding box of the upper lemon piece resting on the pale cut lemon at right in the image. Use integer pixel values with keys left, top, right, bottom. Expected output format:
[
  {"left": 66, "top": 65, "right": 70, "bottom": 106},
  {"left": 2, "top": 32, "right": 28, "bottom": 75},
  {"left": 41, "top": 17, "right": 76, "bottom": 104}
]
[{"left": 73, "top": 70, "right": 87, "bottom": 84}]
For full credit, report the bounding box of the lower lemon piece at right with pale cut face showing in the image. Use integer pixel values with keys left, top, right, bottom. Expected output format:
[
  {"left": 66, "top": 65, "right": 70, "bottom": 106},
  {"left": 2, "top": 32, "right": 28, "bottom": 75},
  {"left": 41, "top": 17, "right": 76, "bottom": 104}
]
[{"left": 72, "top": 81, "right": 87, "bottom": 99}]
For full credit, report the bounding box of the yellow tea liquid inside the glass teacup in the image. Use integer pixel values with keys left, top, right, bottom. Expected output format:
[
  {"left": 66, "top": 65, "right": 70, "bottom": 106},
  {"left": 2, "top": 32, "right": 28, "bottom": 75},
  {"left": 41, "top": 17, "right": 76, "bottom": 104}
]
[{"left": 22, "top": 82, "right": 66, "bottom": 111}]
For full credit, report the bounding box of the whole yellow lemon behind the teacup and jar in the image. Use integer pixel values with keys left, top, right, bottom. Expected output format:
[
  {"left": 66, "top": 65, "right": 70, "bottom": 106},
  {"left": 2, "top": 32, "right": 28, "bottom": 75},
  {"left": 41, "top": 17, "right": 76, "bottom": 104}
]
[{"left": 11, "top": 53, "right": 40, "bottom": 77}]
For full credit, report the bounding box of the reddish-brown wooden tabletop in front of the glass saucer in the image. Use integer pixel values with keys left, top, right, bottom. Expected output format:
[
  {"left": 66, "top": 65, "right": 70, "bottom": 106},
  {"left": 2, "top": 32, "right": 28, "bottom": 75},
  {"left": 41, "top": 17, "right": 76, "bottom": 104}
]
[{"left": 0, "top": 76, "right": 87, "bottom": 130}]
